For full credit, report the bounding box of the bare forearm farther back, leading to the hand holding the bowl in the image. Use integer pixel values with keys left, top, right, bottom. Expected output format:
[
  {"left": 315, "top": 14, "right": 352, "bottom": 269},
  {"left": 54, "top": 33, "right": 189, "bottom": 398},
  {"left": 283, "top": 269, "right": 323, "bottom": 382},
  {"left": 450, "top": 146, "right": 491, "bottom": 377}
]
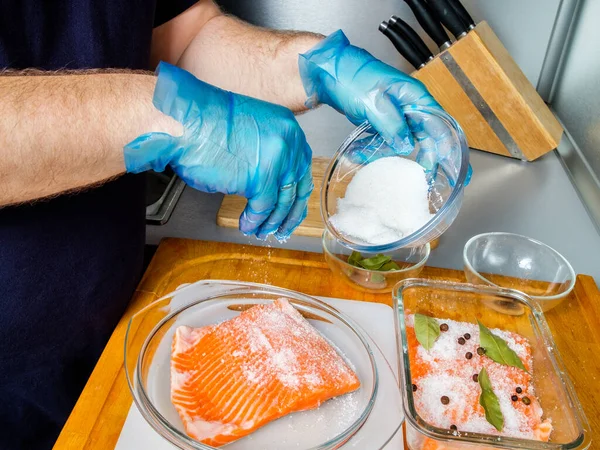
[{"left": 178, "top": 15, "right": 323, "bottom": 111}]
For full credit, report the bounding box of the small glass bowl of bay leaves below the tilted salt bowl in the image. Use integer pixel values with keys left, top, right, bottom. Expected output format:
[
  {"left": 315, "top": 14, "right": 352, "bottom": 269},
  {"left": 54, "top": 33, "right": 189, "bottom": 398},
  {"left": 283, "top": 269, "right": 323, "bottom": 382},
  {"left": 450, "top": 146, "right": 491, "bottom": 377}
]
[{"left": 322, "top": 230, "right": 430, "bottom": 293}]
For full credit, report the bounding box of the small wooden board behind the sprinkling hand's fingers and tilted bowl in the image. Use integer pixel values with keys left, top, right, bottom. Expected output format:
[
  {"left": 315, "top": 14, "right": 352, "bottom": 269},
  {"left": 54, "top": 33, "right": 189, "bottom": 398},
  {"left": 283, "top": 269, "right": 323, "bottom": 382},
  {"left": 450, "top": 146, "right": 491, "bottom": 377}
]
[{"left": 217, "top": 158, "right": 330, "bottom": 237}]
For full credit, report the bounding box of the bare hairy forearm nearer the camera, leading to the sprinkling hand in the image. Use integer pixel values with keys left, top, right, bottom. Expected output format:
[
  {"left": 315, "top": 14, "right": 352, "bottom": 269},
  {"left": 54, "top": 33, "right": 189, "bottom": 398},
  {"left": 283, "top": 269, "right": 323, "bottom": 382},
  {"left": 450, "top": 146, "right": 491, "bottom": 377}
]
[{"left": 0, "top": 72, "right": 181, "bottom": 206}]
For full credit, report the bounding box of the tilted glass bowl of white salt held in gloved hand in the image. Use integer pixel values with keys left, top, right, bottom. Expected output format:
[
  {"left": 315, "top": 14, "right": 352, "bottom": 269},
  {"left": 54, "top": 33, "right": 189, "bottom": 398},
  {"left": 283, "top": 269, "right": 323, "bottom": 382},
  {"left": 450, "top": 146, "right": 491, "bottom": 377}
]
[{"left": 321, "top": 106, "right": 470, "bottom": 254}]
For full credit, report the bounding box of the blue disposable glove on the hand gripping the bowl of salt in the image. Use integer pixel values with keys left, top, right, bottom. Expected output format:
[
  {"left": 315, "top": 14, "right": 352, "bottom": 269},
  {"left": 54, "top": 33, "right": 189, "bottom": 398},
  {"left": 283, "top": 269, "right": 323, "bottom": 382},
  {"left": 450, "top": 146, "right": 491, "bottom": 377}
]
[{"left": 298, "top": 30, "right": 471, "bottom": 183}]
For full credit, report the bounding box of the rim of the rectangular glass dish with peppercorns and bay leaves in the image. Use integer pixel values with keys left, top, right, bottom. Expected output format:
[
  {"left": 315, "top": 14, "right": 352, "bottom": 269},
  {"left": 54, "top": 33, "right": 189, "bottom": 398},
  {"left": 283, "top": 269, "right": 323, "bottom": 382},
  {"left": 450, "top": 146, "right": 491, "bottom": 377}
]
[{"left": 392, "top": 278, "right": 590, "bottom": 450}]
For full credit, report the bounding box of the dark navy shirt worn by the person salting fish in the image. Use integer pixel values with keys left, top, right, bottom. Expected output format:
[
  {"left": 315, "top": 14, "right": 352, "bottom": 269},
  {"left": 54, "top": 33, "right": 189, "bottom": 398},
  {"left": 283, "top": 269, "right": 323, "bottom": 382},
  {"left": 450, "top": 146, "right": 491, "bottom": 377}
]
[{"left": 0, "top": 0, "right": 195, "bottom": 450}]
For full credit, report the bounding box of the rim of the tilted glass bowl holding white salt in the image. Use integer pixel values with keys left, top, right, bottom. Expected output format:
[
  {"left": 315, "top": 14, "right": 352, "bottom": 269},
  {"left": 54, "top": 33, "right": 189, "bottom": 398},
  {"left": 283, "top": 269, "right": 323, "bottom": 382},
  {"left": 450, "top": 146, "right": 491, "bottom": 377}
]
[{"left": 321, "top": 105, "right": 469, "bottom": 252}]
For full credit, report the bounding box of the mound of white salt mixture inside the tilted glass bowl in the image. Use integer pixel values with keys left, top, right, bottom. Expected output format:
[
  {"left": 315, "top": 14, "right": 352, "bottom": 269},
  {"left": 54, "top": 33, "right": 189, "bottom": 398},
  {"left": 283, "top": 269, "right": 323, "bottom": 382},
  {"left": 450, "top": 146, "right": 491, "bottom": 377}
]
[{"left": 331, "top": 156, "right": 432, "bottom": 245}]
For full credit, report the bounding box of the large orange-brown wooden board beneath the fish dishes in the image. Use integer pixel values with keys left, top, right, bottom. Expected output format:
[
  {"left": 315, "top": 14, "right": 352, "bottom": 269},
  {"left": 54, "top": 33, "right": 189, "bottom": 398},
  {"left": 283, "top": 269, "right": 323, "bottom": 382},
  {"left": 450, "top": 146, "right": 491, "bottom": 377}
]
[{"left": 54, "top": 239, "right": 600, "bottom": 450}]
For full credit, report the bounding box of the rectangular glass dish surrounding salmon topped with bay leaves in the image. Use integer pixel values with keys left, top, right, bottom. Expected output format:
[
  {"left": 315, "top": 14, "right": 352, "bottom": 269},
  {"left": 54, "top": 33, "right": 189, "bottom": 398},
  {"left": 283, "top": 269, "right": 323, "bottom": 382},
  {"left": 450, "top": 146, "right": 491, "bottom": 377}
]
[{"left": 393, "top": 279, "right": 590, "bottom": 450}]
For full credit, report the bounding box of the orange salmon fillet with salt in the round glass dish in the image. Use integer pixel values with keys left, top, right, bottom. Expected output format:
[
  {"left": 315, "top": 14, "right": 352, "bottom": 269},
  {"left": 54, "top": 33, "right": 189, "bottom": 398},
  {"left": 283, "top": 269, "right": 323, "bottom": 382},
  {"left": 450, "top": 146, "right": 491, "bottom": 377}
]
[{"left": 171, "top": 298, "right": 360, "bottom": 447}]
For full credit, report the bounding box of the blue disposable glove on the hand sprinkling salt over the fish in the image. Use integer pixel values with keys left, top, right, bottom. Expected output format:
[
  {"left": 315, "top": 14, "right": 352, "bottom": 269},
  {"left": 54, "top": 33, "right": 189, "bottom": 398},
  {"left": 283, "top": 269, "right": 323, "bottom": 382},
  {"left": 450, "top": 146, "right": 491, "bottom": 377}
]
[{"left": 124, "top": 63, "right": 313, "bottom": 240}]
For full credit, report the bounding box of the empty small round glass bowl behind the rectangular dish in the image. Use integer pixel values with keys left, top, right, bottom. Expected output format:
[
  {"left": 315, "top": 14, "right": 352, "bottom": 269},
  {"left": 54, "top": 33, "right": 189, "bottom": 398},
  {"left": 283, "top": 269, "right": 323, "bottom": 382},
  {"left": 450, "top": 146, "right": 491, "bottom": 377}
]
[{"left": 463, "top": 233, "right": 576, "bottom": 311}]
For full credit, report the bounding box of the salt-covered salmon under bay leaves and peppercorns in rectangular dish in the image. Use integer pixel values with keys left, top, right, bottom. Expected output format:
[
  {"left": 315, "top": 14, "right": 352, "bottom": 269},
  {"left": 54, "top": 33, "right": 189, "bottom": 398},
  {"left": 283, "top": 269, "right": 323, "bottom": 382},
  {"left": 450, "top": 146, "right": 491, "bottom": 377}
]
[{"left": 406, "top": 315, "right": 552, "bottom": 450}]
